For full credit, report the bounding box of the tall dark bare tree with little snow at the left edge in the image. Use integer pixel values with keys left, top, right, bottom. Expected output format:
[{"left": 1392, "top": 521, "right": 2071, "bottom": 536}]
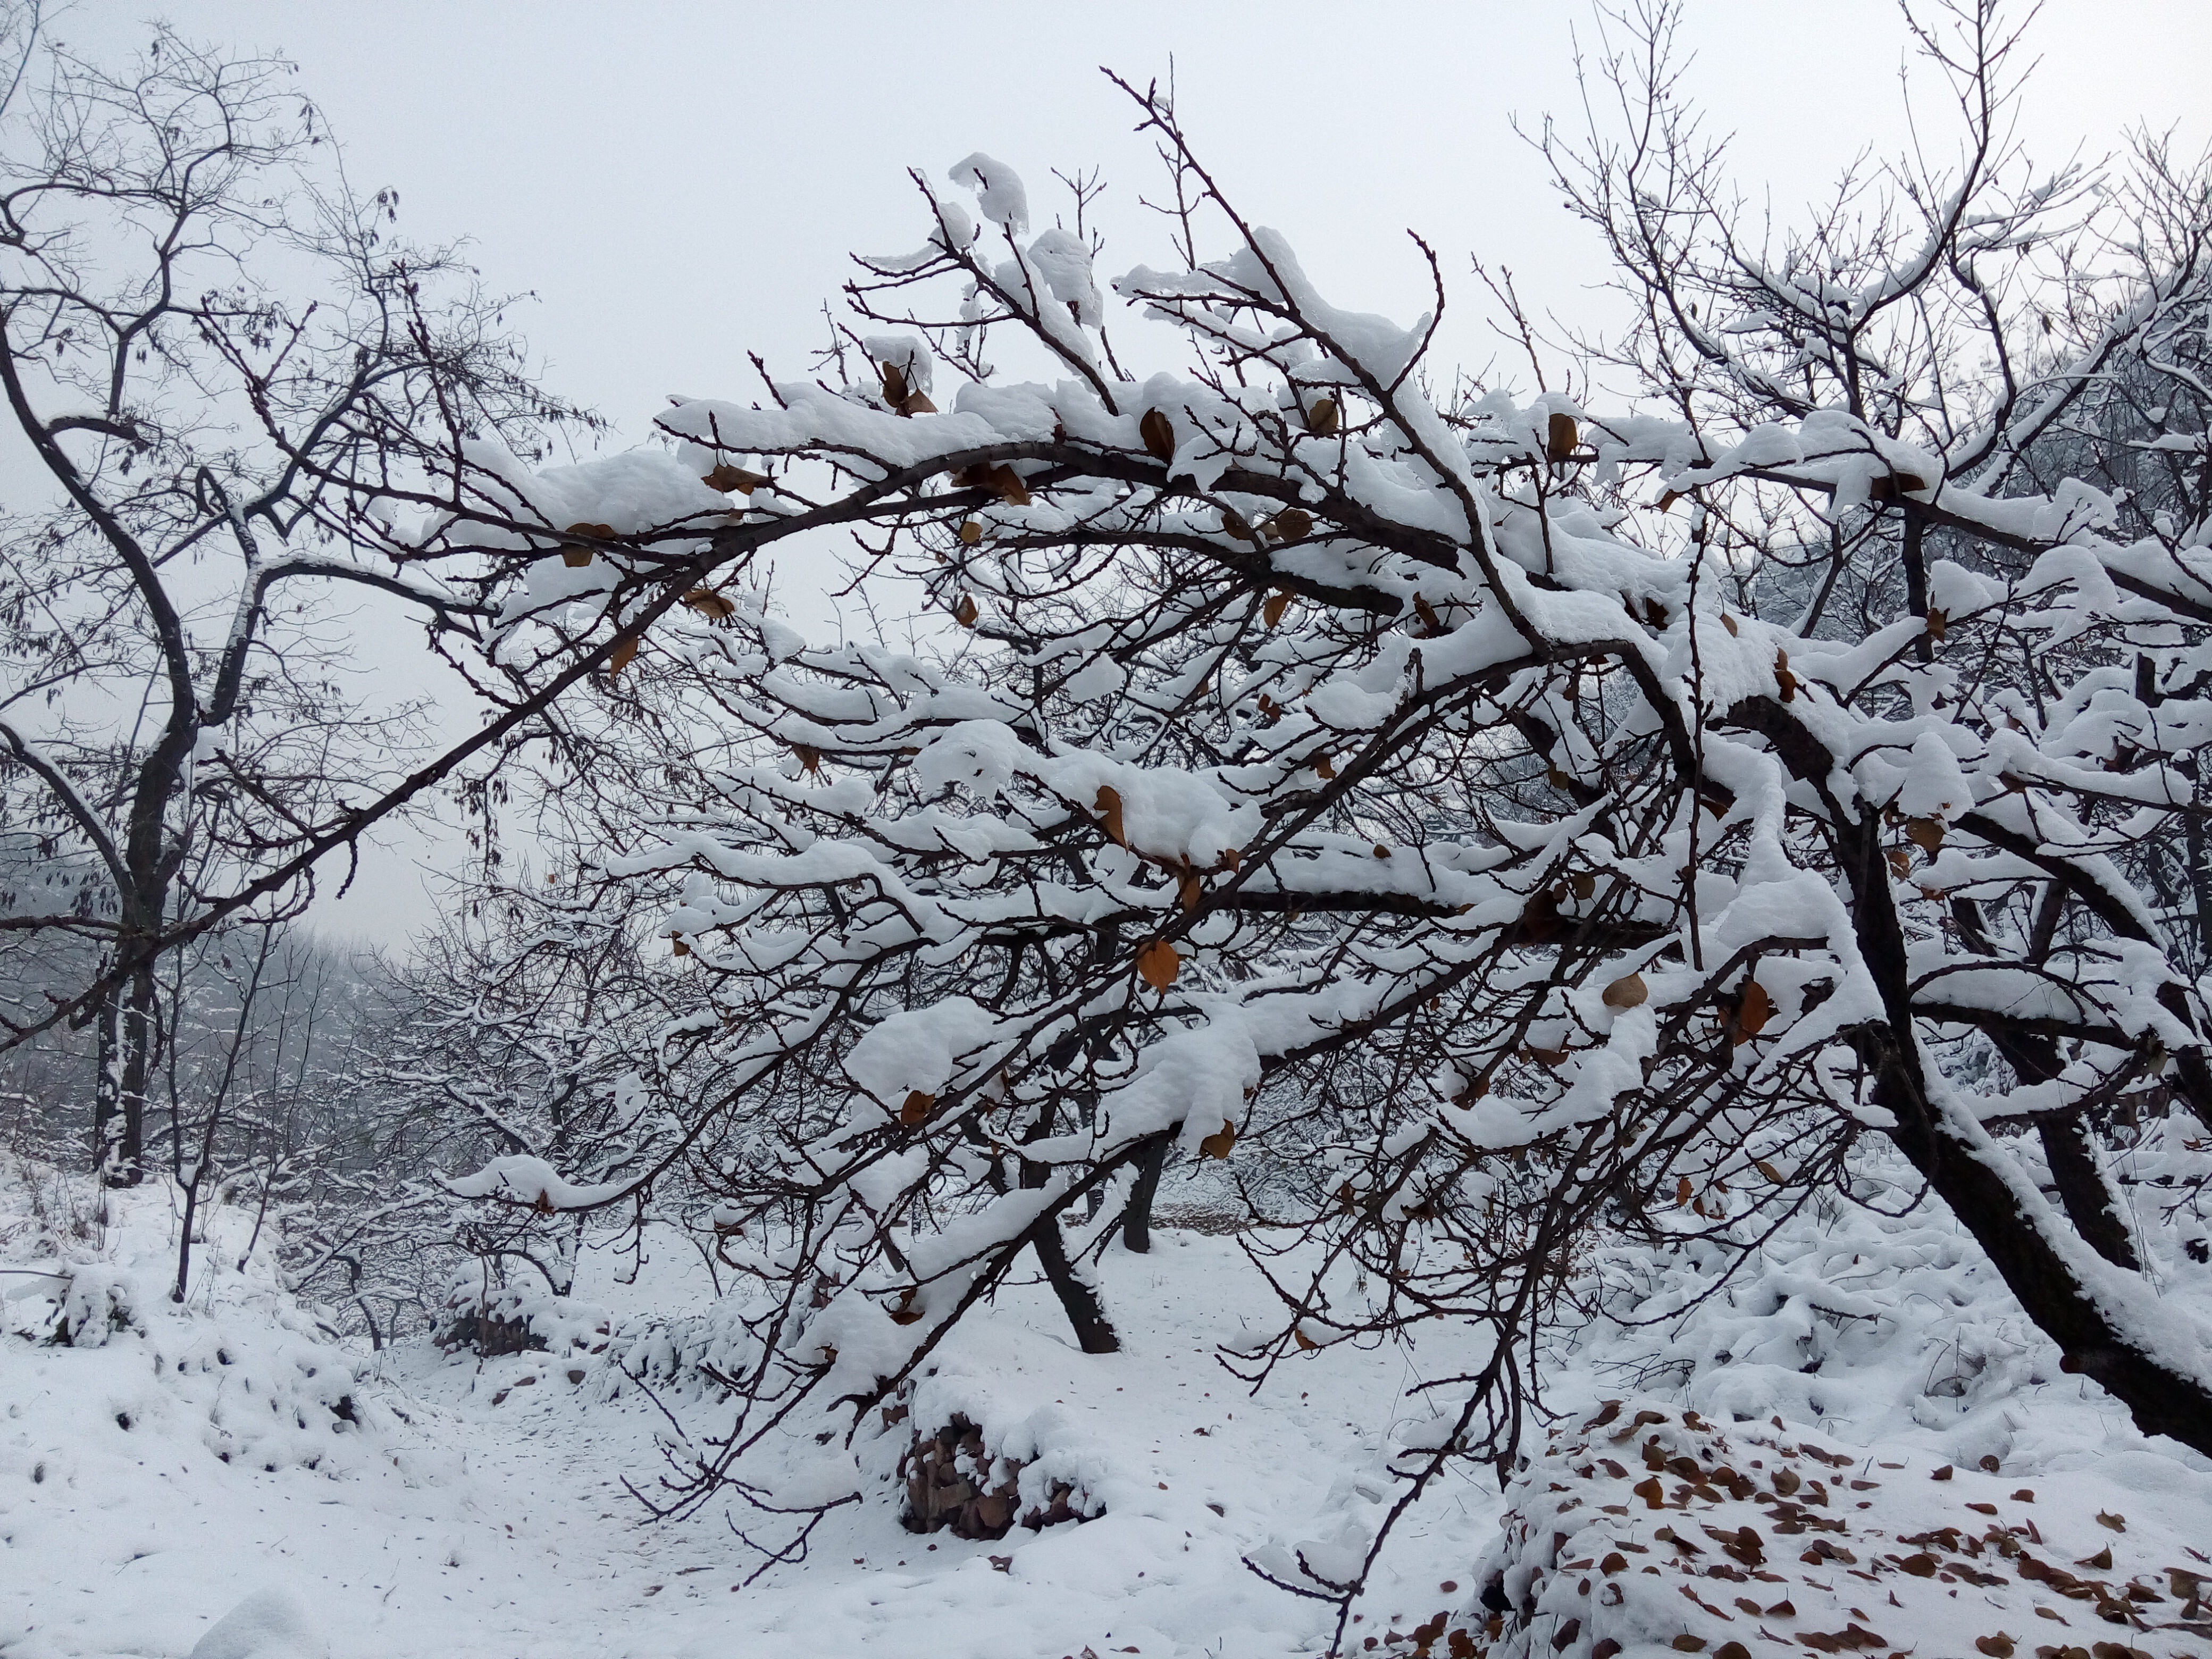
[{"left": 0, "top": 4, "right": 752, "bottom": 1184}]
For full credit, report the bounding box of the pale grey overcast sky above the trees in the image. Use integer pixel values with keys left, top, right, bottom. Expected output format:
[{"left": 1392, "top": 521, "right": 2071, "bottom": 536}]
[{"left": 55, "top": 0, "right": 2212, "bottom": 942}]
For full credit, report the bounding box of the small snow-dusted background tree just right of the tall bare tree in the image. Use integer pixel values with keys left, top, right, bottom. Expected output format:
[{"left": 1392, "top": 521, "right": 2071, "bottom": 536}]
[{"left": 290, "top": 889, "right": 681, "bottom": 1338}]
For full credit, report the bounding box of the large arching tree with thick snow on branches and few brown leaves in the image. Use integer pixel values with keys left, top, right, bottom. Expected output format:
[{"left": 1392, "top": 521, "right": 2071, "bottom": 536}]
[{"left": 422, "top": 4, "right": 2212, "bottom": 1588}]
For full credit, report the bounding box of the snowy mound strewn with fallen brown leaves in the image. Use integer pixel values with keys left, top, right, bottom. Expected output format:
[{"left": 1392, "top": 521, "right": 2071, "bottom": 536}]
[{"left": 1457, "top": 1400, "right": 2212, "bottom": 1659}]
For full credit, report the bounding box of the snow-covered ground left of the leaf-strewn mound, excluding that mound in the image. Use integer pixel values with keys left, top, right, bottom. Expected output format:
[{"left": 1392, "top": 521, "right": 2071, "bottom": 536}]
[{"left": 0, "top": 1168, "right": 1499, "bottom": 1659}]
